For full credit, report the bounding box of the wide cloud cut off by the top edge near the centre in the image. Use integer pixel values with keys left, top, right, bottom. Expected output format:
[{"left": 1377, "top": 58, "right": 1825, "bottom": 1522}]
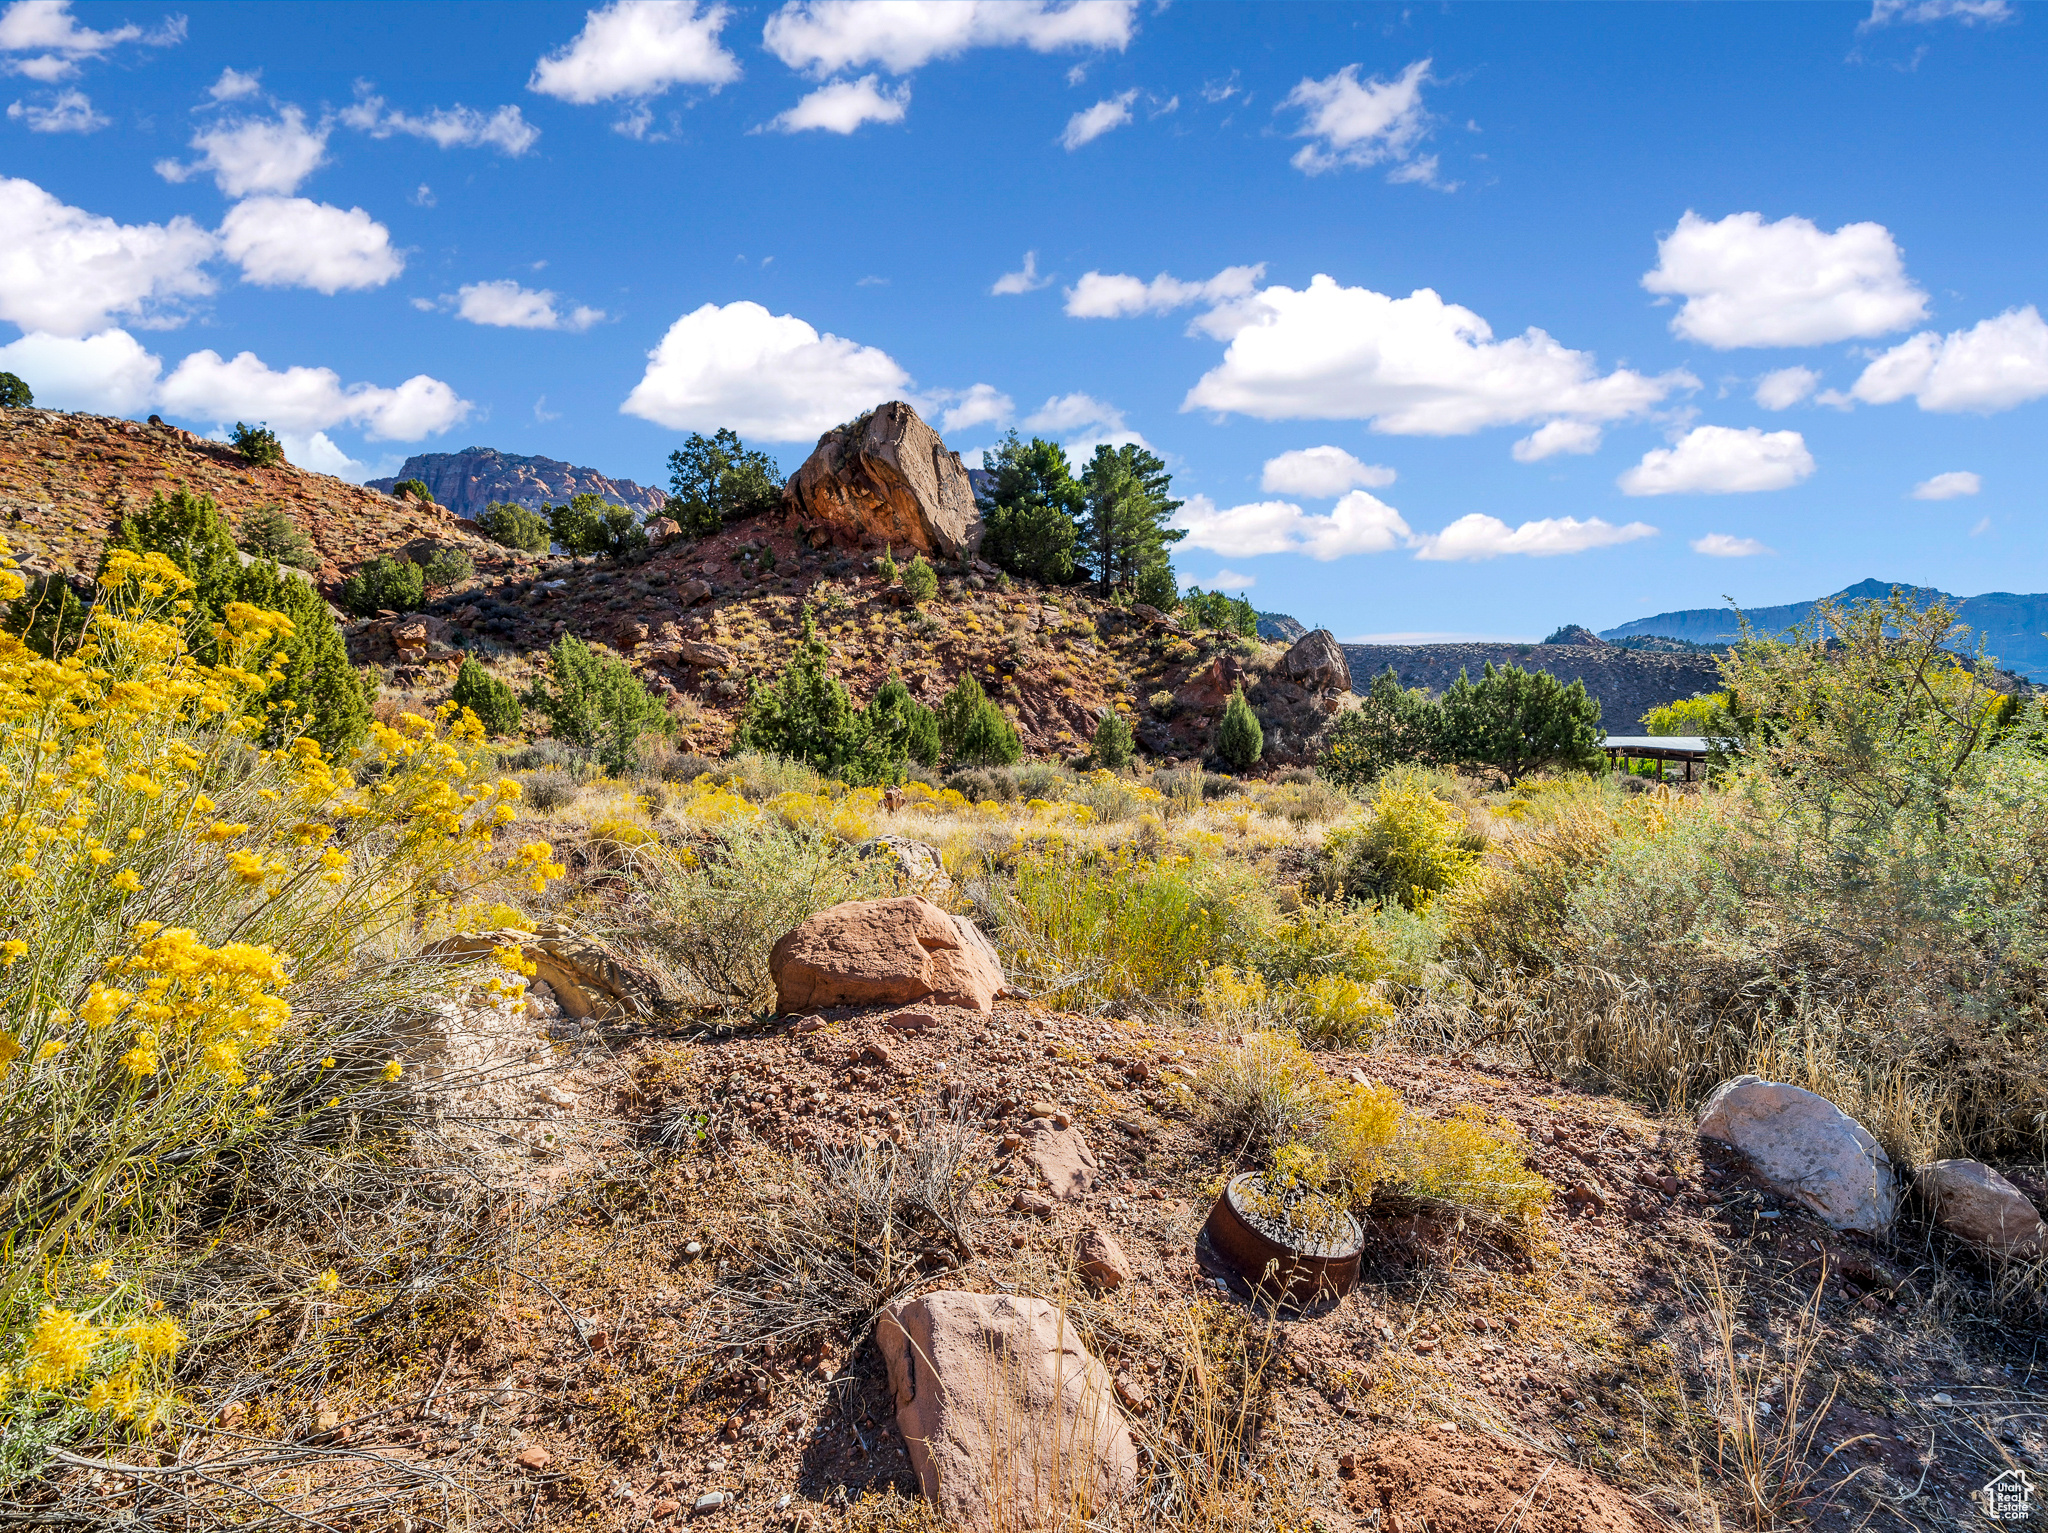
[{"left": 762, "top": 0, "right": 1137, "bottom": 76}]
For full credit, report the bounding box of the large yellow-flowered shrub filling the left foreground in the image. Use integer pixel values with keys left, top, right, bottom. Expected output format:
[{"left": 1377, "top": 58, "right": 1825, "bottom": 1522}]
[{"left": 0, "top": 546, "right": 561, "bottom": 1470}]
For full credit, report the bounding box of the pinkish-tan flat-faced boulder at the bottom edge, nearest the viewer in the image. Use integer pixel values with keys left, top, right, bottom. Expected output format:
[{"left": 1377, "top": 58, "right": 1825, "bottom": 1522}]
[{"left": 874, "top": 1289, "right": 1139, "bottom": 1533}]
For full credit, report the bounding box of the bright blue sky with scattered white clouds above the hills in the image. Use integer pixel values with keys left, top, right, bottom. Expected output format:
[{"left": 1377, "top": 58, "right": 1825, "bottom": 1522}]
[{"left": 0, "top": 0, "right": 2048, "bottom": 637}]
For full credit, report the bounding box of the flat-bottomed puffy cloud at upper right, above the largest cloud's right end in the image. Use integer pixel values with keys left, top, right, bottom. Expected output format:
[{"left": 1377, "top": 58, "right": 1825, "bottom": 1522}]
[{"left": 1642, "top": 211, "right": 1927, "bottom": 350}]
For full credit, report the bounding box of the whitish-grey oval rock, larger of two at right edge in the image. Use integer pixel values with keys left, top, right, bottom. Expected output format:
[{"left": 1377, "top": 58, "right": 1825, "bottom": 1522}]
[{"left": 1700, "top": 1075, "right": 1898, "bottom": 1234}]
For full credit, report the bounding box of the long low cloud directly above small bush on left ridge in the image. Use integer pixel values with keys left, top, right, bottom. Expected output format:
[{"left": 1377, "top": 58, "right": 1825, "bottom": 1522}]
[{"left": 158, "top": 350, "right": 475, "bottom": 442}]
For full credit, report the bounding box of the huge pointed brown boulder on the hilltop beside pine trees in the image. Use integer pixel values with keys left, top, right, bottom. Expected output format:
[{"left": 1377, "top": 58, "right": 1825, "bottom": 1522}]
[{"left": 782, "top": 399, "right": 981, "bottom": 559}]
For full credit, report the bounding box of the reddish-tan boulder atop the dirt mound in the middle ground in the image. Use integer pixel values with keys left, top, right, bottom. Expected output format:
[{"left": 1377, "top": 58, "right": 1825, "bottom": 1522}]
[{"left": 768, "top": 894, "right": 1004, "bottom": 1015}]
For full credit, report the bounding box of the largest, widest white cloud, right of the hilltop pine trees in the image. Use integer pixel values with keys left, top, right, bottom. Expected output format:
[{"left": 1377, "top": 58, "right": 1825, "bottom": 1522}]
[{"left": 1182, "top": 274, "right": 1698, "bottom": 436}]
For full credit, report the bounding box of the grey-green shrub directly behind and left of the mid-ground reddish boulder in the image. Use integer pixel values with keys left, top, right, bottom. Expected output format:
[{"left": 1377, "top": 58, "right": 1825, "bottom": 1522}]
[{"left": 635, "top": 815, "right": 895, "bottom": 1009}]
